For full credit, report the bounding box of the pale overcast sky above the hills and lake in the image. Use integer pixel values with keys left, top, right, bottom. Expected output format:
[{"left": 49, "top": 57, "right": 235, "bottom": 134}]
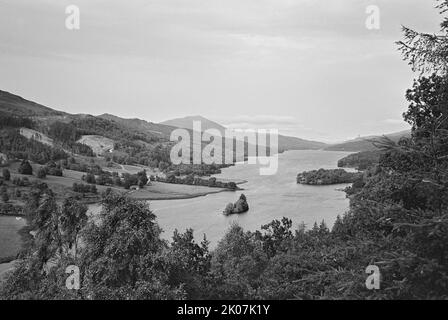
[{"left": 0, "top": 0, "right": 440, "bottom": 141}]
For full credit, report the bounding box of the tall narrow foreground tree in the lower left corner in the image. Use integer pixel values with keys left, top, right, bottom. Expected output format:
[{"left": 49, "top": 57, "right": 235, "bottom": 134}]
[{"left": 0, "top": 188, "right": 84, "bottom": 300}]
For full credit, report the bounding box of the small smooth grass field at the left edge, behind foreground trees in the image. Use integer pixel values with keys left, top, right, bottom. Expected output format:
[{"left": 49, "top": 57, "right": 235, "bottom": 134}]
[{"left": 0, "top": 216, "right": 26, "bottom": 258}]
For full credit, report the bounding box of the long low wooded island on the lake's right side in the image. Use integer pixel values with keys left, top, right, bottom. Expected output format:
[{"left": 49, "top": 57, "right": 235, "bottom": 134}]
[{"left": 297, "top": 169, "right": 362, "bottom": 186}]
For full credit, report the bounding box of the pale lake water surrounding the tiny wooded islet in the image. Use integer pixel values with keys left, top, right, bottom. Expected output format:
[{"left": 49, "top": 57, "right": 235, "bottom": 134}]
[{"left": 150, "top": 151, "right": 354, "bottom": 247}]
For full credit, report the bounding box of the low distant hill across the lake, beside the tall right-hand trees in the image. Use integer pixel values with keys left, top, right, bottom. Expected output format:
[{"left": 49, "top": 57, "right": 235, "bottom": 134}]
[{"left": 324, "top": 130, "right": 411, "bottom": 152}]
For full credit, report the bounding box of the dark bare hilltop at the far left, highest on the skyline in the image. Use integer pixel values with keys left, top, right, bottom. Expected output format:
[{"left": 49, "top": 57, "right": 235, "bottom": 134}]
[{"left": 0, "top": 90, "right": 67, "bottom": 117}]
